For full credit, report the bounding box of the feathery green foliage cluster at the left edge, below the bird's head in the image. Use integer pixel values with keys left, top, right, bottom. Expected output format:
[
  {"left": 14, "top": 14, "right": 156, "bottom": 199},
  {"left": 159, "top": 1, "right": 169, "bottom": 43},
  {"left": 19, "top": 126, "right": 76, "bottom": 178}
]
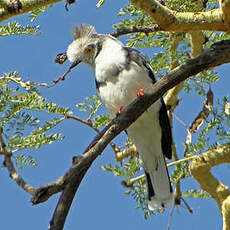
[{"left": 0, "top": 72, "right": 70, "bottom": 168}]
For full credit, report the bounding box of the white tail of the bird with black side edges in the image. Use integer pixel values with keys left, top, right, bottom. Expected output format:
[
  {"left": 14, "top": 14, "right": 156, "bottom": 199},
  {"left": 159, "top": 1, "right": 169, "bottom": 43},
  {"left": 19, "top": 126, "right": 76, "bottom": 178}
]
[{"left": 145, "top": 154, "right": 174, "bottom": 210}]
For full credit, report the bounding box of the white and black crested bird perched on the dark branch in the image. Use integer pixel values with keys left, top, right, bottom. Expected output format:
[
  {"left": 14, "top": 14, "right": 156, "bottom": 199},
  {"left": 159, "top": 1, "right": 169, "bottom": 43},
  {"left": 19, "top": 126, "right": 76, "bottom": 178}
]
[{"left": 66, "top": 24, "right": 174, "bottom": 210}]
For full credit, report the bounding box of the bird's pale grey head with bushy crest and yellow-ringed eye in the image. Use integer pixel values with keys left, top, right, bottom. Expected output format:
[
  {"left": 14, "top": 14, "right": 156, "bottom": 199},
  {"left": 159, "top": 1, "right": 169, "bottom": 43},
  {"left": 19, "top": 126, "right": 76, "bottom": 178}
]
[{"left": 67, "top": 24, "right": 101, "bottom": 66}]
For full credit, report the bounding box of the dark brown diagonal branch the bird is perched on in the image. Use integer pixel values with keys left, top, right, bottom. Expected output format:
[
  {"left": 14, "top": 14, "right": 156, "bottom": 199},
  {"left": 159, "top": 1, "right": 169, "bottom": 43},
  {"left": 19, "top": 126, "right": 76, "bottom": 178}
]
[{"left": 29, "top": 40, "right": 230, "bottom": 230}]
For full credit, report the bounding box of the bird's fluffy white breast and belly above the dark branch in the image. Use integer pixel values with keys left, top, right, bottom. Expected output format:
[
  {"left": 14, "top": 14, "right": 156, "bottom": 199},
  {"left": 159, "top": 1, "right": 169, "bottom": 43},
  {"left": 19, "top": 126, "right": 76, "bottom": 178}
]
[{"left": 95, "top": 41, "right": 156, "bottom": 117}]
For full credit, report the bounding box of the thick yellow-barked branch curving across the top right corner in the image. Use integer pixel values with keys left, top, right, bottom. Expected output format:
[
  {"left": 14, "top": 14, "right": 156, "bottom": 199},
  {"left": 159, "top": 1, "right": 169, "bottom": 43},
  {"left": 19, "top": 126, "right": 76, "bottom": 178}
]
[{"left": 129, "top": 0, "right": 230, "bottom": 32}]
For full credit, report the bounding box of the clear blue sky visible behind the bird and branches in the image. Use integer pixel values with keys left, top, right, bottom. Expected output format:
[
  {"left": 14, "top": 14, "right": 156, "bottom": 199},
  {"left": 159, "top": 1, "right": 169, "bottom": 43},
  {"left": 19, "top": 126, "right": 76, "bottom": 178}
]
[{"left": 0, "top": 0, "right": 230, "bottom": 230}]
